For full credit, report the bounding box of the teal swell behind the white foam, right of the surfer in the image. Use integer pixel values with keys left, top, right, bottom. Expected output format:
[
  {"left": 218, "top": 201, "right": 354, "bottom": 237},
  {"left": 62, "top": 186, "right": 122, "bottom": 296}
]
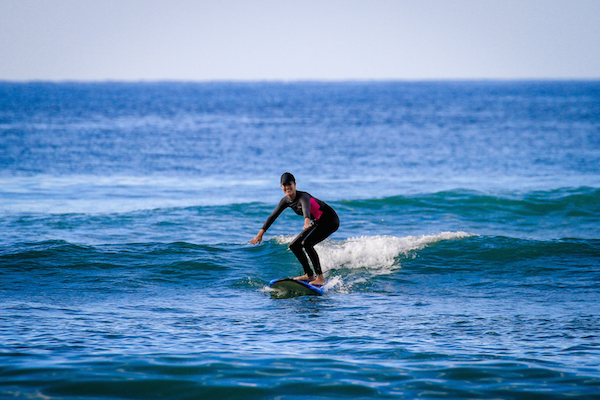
[{"left": 343, "top": 187, "right": 600, "bottom": 239}]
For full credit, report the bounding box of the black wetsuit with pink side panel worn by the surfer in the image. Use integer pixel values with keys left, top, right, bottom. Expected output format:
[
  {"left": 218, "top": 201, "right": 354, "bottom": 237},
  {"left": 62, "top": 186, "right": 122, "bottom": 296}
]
[{"left": 263, "top": 190, "right": 340, "bottom": 276}]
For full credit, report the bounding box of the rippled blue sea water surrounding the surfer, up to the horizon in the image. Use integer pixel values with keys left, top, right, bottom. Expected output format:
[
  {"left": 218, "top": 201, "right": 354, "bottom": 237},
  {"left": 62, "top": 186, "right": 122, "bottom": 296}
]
[{"left": 0, "top": 81, "right": 600, "bottom": 400}]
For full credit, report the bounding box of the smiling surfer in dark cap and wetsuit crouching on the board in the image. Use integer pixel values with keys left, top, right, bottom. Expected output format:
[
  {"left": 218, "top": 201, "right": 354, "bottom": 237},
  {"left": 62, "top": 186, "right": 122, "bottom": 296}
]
[{"left": 250, "top": 172, "right": 340, "bottom": 285}]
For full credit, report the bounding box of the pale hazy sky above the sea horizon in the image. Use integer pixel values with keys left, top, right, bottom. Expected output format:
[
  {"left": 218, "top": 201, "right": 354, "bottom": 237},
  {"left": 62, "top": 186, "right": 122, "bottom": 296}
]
[{"left": 0, "top": 0, "right": 600, "bottom": 81}]
